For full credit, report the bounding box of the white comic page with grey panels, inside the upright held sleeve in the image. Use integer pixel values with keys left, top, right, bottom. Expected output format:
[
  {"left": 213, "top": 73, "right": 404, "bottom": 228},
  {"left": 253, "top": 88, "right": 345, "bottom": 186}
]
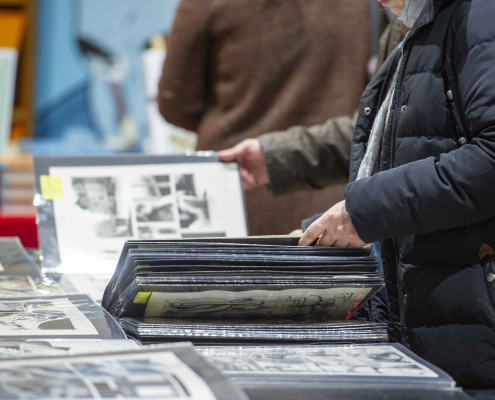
[{"left": 50, "top": 163, "right": 247, "bottom": 273}]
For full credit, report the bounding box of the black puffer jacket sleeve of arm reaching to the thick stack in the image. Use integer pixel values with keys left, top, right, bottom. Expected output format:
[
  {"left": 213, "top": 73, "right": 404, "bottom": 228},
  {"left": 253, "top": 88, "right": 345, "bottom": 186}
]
[{"left": 346, "top": 0, "right": 495, "bottom": 243}]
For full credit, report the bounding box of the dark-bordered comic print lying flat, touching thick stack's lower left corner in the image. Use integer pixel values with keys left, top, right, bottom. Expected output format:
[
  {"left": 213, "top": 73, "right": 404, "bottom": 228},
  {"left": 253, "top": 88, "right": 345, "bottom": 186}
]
[{"left": 0, "top": 295, "right": 127, "bottom": 340}]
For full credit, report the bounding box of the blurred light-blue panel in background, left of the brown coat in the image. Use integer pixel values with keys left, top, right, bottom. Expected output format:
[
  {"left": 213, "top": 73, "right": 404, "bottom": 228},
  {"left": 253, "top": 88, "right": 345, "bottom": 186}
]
[{"left": 33, "top": 0, "right": 179, "bottom": 152}]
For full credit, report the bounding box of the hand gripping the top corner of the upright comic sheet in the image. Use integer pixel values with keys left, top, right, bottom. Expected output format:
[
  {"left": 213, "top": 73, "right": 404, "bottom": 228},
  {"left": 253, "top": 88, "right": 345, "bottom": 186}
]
[{"left": 218, "top": 139, "right": 270, "bottom": 190}]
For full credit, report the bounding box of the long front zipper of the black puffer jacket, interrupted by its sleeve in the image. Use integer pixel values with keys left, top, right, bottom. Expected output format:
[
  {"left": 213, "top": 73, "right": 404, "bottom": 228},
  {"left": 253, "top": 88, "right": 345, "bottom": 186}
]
[{"left": 389, "top": 40, "right": 413, "bottom": 346}]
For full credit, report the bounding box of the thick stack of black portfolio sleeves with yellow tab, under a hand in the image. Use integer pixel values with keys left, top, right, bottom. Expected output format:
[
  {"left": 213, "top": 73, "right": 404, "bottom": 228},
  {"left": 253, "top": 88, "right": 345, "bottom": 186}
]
[{"left": 102, "top": 237, "right": 388, "bottom": 343}]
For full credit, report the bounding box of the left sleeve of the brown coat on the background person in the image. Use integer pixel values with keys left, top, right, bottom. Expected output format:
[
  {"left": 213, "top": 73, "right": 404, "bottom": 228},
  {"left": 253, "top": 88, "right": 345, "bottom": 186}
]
[{"left": 158, "top": 0, "right": 211, "bottom": 131}]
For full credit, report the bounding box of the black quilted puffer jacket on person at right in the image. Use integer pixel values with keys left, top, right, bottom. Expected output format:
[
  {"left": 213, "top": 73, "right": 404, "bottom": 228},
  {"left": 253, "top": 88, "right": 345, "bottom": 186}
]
[{"left": 346, "top": 0, "right": 495, "bottom": 389}]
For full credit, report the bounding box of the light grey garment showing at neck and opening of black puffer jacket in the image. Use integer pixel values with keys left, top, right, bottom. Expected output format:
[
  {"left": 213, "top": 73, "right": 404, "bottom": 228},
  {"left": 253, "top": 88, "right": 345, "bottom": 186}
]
[{"left": 357, "top": 0, "right": 429, "bottom": 179}]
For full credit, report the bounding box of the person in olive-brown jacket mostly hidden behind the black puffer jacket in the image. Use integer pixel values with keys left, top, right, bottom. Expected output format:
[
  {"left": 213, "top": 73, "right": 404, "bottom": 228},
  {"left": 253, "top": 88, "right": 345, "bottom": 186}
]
[{"left": 219, "top": 19, "right": 404, "bottom": 205}]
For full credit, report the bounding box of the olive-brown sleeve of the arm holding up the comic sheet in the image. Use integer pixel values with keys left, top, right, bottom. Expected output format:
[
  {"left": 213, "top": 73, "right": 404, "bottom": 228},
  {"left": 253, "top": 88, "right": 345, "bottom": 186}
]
[{"left": 258, "top": 114, "right": 357, "bottom": 195}]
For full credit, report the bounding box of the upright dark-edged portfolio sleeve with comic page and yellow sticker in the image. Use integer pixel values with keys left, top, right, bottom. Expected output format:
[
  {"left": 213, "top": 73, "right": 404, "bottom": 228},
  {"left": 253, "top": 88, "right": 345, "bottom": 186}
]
[{"left": 34, "top": 153, "right": 247, "bottom": 274}]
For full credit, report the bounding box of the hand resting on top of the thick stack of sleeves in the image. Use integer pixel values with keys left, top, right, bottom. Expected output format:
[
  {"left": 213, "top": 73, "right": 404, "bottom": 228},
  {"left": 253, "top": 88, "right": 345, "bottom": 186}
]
[{"left": 299, "top": 201, "right": 366, "bottom": 247}]
